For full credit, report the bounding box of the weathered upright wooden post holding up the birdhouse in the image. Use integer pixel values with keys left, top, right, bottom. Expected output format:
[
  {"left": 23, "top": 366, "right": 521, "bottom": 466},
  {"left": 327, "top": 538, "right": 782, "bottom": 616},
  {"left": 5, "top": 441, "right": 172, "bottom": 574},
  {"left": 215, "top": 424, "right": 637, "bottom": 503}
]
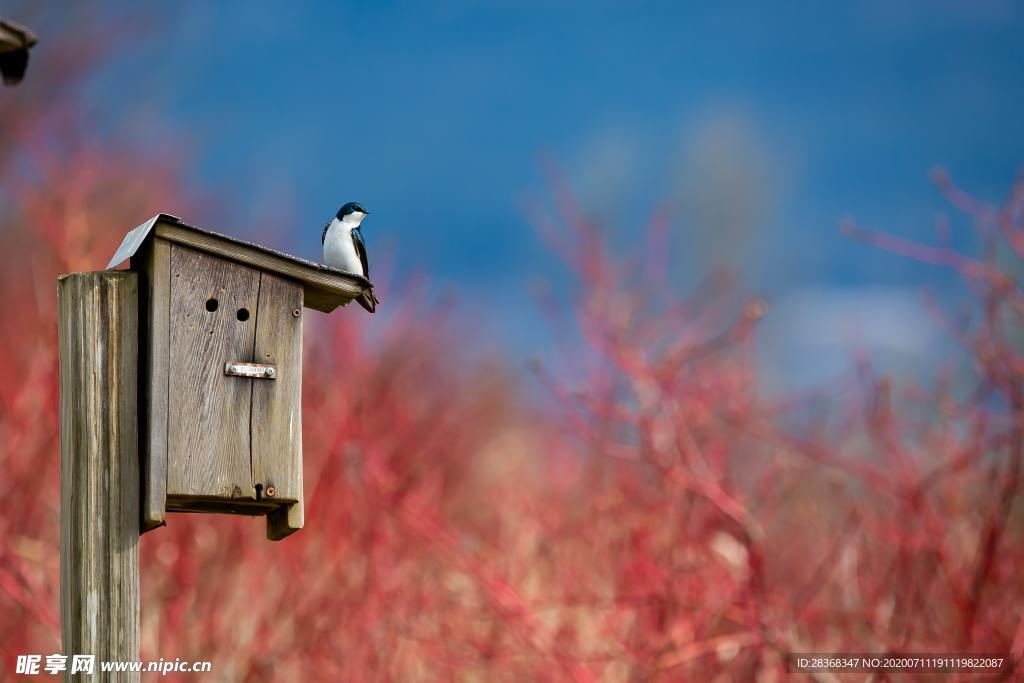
[{"left": 57, "top": 271, "right": 140, "bottom": 682}]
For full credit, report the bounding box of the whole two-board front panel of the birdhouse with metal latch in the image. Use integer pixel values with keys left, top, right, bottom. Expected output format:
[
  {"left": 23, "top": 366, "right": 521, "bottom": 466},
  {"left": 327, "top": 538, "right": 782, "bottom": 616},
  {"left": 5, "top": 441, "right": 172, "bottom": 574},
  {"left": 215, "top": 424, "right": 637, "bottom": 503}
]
[{"left": 161, "top": 245, "right": 302, "bottom": 514}]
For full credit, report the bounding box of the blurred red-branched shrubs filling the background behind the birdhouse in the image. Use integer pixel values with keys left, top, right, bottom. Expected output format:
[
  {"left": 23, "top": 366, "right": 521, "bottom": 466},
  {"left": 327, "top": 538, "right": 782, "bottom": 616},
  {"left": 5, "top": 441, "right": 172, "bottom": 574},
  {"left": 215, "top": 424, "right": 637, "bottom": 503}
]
[{"left": 0, "top": 17, "right": 1024, "bottom": 681}]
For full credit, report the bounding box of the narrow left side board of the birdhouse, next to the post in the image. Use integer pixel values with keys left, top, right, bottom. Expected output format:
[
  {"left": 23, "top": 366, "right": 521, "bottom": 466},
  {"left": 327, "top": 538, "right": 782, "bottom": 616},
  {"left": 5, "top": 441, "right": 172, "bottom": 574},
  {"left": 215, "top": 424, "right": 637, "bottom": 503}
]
[{"left": 132, "top": 240, "right": 171, "bottom": 531}]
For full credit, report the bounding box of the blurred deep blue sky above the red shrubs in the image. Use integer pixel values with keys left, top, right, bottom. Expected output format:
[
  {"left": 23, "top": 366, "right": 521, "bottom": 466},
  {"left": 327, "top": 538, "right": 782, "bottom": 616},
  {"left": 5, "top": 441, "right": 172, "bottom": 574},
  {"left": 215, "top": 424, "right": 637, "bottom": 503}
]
[{"left": 70, "top": 1, "right": 1024, "bottom": 385}]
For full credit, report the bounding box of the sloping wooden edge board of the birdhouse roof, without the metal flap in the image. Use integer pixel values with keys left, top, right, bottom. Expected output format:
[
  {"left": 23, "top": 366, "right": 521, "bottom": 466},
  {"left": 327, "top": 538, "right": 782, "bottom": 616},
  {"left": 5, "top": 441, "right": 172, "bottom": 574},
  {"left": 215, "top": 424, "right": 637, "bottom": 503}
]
[{"left": 154, "top": 222, "right": 369, "bottom": 313}]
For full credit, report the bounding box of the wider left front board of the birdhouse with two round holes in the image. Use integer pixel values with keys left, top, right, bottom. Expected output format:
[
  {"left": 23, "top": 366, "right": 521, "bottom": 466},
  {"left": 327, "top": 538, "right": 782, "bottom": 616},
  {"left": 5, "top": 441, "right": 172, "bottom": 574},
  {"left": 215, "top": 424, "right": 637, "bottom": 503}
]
[{"left": 167, "top": 245, "right": 260, "bottom": 501}]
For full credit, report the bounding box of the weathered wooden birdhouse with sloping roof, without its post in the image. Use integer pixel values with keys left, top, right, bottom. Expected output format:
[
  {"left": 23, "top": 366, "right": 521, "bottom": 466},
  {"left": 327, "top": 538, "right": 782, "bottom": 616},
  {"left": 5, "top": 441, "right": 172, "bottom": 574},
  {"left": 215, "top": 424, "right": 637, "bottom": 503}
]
[{"left": 108, "top": 214, "right": 371, "bottom": 540}]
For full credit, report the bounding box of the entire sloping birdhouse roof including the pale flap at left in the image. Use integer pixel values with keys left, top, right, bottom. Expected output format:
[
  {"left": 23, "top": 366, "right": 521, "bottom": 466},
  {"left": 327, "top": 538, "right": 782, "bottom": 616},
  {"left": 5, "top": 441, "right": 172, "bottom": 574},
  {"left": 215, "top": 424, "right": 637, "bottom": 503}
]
[{"left": 106, "top": 213, "right": 373, "bottom": 313}]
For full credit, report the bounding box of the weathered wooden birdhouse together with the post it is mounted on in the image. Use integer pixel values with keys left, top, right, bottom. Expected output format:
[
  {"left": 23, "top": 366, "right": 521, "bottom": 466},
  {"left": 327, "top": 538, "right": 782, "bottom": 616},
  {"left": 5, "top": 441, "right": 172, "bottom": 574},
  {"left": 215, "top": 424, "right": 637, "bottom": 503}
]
[{"left": 57, "top": 214, "right": 372, "bottom": 681}]
